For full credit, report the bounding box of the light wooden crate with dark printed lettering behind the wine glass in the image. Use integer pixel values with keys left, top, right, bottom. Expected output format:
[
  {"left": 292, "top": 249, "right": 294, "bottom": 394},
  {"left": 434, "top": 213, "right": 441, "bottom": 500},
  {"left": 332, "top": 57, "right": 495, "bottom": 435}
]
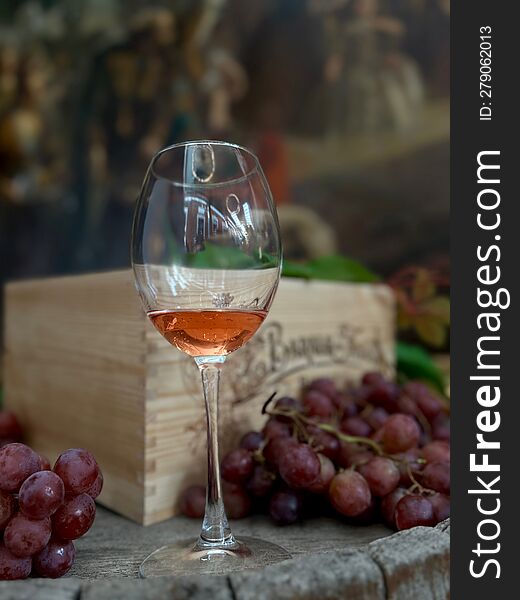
[{"left": 4, "top": 271, "right": 394, "bottom": 524}]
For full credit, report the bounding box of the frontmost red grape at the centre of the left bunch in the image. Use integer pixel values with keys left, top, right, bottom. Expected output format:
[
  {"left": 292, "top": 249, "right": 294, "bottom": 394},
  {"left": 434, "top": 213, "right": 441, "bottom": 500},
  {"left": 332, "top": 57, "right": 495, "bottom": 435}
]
[{"left": 18, "top": 471, "right": 65, "bottom": 519}]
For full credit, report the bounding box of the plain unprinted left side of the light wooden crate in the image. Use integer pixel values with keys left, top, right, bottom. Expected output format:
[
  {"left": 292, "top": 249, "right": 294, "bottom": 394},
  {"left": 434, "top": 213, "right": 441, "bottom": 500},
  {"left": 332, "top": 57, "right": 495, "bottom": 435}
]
[{"left": 4, "top": 272, "right": 146, "bottom": 521}]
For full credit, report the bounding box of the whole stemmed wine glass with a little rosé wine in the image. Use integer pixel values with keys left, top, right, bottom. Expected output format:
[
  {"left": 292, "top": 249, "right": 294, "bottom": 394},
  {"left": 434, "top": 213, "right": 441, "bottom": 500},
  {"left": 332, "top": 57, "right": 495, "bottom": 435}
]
[{"left": 132, "top": 141, "right": 290, "bottom": 577}]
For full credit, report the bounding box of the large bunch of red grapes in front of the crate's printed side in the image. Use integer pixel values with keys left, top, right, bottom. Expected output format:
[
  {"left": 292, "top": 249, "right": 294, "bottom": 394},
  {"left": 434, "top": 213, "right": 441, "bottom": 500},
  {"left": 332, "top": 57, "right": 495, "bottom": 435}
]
[{"left": 181, "top": 373, "right": 450, "bottom": 530}]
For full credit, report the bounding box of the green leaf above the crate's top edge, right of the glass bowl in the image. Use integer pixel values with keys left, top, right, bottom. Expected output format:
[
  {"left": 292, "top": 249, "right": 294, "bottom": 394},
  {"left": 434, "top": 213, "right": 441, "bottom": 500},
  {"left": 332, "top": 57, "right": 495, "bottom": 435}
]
[{"left": 282, "top": 255, "right": 380, "bottom": 283}]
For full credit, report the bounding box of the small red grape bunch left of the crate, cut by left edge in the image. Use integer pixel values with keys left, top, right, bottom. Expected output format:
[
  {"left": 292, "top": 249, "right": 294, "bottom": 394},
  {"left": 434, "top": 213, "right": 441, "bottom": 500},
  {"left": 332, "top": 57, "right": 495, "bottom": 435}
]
[{"left": 0, "top": 442, "right": 103, "bottom": 580}]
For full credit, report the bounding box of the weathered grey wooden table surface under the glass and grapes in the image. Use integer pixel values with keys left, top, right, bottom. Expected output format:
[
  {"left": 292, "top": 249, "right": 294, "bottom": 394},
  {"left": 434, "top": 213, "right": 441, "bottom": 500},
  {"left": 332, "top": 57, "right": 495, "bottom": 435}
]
[{"left": 0, "top": 507, "right": 449, "bottom": 600}]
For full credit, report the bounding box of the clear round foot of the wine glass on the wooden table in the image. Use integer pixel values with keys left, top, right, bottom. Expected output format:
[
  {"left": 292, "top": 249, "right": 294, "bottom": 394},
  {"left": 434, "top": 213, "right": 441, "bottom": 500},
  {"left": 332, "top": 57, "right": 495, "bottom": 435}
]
[{"left": 139, "top": 537, "right": 291, "bottom": 578}]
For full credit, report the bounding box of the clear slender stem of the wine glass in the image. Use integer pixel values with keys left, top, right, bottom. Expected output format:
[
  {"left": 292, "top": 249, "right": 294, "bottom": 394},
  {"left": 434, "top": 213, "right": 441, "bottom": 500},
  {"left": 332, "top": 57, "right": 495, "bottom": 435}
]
[{"left": 195, "top": 356, "right": 234, "bottom": 546}]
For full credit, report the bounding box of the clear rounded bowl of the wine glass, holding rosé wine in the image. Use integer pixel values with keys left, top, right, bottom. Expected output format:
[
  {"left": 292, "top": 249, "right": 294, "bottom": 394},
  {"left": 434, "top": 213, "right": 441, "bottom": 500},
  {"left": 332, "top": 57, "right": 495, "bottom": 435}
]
[{"left": 132, "top": 142, "right": 281, "bottom": 356}]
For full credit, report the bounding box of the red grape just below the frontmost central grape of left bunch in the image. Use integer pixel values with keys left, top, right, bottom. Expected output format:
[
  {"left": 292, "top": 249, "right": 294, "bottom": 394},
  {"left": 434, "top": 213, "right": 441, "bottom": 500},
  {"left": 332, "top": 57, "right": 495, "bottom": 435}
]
[{"left": 4, "top": 513, "right": 51, "bottom": 558}]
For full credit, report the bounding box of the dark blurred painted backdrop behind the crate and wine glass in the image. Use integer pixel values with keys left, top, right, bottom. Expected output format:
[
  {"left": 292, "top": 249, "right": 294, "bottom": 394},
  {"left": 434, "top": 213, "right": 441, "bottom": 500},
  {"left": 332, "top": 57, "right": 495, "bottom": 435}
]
[{"left": 0, "top": 0, "right": 450, "bottom": 324}]
